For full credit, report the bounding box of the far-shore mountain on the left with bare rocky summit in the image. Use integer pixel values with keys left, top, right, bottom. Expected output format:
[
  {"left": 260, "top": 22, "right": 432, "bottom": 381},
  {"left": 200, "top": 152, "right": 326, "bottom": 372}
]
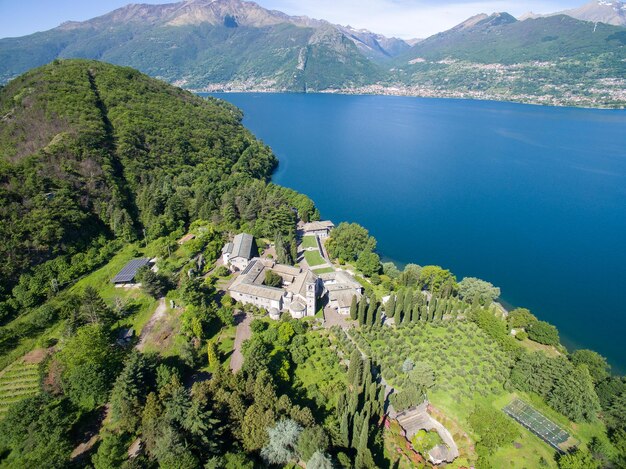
[{"left": 0, "top": 0, "right": 408, "bottom": 90}]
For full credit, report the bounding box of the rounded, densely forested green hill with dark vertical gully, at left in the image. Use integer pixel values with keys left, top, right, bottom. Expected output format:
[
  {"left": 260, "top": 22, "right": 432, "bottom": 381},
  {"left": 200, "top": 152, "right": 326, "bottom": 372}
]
[{"left": 0, "top": 60, "right": 312, "bottom": 308}]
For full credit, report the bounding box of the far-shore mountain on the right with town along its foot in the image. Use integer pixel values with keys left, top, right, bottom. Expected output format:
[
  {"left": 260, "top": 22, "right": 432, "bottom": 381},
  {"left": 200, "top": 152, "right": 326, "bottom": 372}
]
[{"left": 389, "top": 13, "right": 626, "bottom": 107}]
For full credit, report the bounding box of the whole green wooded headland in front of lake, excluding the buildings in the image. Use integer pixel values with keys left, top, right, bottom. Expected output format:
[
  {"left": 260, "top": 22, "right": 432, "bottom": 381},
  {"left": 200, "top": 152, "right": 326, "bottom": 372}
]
[{"left": 0, "top": 60, "right": 626, "bottom": 469}]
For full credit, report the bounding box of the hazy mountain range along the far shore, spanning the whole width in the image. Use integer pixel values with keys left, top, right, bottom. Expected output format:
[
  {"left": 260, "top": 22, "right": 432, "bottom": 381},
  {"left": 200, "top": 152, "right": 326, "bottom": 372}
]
[{"left": 0, "top": 0, "right": 626, "bottom": 106}]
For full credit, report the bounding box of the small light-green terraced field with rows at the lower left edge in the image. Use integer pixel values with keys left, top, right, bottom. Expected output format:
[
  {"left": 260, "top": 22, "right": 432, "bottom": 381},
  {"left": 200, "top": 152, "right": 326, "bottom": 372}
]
[{"left": 0, "top": 358, "right": 39, "bottom": 418}]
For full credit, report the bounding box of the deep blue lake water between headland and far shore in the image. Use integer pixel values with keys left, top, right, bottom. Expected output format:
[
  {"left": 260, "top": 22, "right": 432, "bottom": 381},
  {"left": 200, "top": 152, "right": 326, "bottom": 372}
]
[{"left": 208, "top": 94, "right": 626, "bottom": 372}]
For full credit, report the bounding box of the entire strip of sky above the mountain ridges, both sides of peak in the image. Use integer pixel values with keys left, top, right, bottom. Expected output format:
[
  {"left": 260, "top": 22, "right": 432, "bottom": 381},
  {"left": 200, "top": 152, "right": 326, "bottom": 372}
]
[{"left": 0, "top": 0, "right": 586, "bottom": 39}]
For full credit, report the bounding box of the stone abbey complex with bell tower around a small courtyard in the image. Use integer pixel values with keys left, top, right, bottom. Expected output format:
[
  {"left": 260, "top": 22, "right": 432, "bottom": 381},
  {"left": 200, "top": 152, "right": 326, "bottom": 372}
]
[{"left": 228, "top": 257, "right": 322, "bottom": 319}]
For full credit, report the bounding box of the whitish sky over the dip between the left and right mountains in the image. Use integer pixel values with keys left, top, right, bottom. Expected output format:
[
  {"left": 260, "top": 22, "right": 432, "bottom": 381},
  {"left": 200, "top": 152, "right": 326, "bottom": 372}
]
[{"left": 258, "top": 0, "right": 579, "bottom": 39}]
